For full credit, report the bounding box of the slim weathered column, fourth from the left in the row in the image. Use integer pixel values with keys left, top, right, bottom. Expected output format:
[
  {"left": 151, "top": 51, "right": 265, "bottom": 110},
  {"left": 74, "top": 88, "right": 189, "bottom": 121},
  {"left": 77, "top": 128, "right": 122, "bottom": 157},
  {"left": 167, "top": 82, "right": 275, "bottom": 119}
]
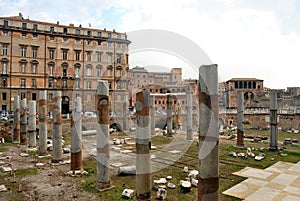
[{"left": 39, "top": 90, "right": 48, "bottom": 156}]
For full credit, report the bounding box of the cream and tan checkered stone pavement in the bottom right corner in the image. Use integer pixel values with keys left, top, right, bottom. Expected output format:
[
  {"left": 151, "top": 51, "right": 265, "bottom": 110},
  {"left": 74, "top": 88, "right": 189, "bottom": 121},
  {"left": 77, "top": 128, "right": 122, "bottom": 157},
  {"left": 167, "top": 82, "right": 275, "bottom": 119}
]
[{"left": 223, "top": 161, "right": 300, "bottom": 201}]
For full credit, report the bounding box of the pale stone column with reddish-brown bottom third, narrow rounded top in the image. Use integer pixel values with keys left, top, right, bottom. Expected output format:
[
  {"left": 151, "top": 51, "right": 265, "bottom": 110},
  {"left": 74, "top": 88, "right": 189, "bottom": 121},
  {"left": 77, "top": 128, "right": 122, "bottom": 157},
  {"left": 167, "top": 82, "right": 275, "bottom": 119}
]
[{"left": 71, "top": 97, "right": 82, "bottom": 171}]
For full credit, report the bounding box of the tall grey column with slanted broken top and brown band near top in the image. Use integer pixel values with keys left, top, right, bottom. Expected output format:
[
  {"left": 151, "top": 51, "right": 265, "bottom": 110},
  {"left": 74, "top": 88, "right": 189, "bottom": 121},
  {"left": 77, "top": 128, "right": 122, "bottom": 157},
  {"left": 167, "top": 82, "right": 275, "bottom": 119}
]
[{"left": 95, "top": 80, "right": 110, "bottom": 189}]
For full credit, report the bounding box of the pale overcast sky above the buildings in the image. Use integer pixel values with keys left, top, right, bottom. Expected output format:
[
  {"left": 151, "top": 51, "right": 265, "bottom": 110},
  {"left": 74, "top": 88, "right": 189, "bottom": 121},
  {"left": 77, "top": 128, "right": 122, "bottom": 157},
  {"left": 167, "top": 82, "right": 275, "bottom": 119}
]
[{"left": 0, "top": 0, "right": 300, "bottom": 88}]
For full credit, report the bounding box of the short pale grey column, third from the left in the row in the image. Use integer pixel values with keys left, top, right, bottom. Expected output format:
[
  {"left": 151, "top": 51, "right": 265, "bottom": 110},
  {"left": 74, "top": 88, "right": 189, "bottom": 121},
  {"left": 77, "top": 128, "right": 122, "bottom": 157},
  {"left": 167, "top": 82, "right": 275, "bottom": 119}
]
[{"left": 28, "top": 100, "right": 36, "bottom": 147}]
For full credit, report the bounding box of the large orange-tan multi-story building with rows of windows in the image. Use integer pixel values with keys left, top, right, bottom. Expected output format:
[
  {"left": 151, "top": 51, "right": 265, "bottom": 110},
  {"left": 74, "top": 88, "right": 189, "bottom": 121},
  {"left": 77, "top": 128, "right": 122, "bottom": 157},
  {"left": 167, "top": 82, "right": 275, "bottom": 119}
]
[{"left": 0, "top": 14, "right": 130, "bottom": 113}]
